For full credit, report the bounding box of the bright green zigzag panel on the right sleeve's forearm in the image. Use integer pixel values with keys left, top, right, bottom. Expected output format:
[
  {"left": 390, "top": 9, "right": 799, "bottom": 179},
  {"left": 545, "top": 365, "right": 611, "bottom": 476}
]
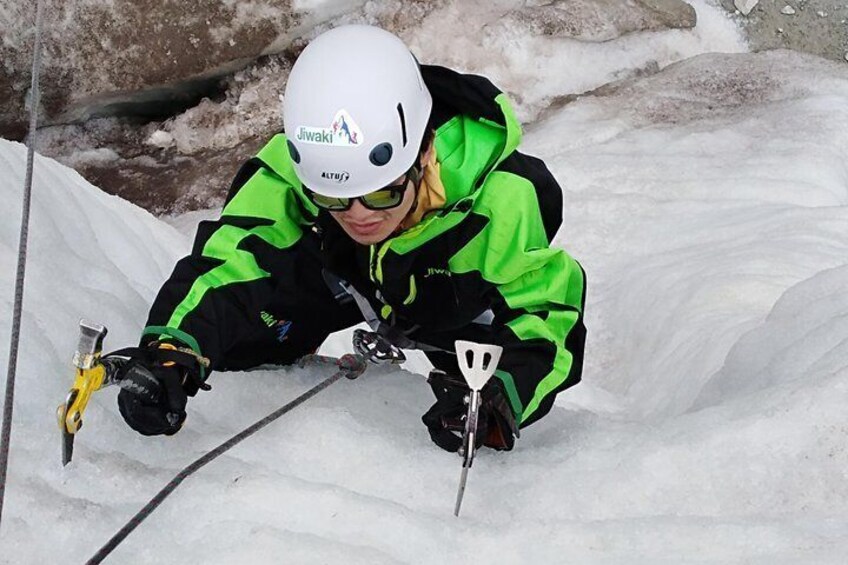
[{"left": 507, "top": 310, "right": 580, "bottom": 422}]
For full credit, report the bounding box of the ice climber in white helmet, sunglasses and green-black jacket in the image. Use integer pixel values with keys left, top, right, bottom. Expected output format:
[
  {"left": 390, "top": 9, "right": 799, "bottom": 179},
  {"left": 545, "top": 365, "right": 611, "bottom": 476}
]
[{"left": 118, "top": 25, "right": 586, "bottom": 451}]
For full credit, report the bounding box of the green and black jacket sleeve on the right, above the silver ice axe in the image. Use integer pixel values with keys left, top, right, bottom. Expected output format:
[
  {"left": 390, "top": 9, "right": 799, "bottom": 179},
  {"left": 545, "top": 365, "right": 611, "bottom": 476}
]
[{"left": 450, "top": 167, "right": 586, "bottom": 426}]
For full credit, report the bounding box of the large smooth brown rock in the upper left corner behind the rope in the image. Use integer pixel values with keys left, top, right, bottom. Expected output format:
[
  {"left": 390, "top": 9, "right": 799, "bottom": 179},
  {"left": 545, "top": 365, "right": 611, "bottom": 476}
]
[{"left": 0, "top": 0, "right": 301, "bottom": 139}]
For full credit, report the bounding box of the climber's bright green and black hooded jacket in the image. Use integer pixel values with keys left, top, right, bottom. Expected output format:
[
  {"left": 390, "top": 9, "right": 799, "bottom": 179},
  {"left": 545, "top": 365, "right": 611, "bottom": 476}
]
[{"left": 145, "top": 66, "right": 585, "bottom": 425}]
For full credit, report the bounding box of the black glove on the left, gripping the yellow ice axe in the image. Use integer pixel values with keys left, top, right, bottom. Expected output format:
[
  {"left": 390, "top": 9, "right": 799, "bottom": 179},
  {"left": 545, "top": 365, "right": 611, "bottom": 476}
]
[{"left": 112, "top": 344, "right": 209, "bottom": 436}]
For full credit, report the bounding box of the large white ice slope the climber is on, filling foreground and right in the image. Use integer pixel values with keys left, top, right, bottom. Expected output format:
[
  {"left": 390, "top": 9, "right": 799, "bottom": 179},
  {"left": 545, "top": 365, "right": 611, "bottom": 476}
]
[{"left": 0, "top": 40, "right": 848, "bottom": 565}]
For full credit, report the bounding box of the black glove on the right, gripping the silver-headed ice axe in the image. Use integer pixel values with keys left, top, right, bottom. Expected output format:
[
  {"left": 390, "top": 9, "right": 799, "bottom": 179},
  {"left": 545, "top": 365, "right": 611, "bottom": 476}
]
[{"left": 421, "top": 370, "right": 519, "bottom": 452}]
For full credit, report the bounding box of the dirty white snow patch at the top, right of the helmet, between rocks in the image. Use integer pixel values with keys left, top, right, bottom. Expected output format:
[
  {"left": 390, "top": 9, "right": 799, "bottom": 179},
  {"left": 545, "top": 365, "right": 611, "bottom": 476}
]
[{"left": 402, "top": 0, "right": 747, "bottom": 122}]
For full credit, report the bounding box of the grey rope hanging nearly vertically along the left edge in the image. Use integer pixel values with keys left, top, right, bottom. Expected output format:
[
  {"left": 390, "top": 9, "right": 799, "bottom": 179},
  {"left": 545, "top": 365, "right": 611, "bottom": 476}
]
[{"left": 0, "top": 0, "right": 44, "bottom": 523}]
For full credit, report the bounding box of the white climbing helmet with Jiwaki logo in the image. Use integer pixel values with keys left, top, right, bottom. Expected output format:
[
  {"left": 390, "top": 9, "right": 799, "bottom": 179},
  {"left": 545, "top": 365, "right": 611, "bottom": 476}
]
[{"left": 283, "top": 25, "right": 433, "bottom": 198}]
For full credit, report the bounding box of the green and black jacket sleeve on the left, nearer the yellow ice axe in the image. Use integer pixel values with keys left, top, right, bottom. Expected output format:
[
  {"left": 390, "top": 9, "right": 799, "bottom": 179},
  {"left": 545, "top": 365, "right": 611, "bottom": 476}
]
[{"left": 142, "top": 135, "right": 313, "bottom": 369}]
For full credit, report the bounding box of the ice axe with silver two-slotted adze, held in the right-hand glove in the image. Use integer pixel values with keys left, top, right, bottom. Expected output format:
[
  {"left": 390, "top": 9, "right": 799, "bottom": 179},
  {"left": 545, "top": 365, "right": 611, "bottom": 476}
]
[{"left": 453, "top": 340, "right": 503, "bottom": 516}]
